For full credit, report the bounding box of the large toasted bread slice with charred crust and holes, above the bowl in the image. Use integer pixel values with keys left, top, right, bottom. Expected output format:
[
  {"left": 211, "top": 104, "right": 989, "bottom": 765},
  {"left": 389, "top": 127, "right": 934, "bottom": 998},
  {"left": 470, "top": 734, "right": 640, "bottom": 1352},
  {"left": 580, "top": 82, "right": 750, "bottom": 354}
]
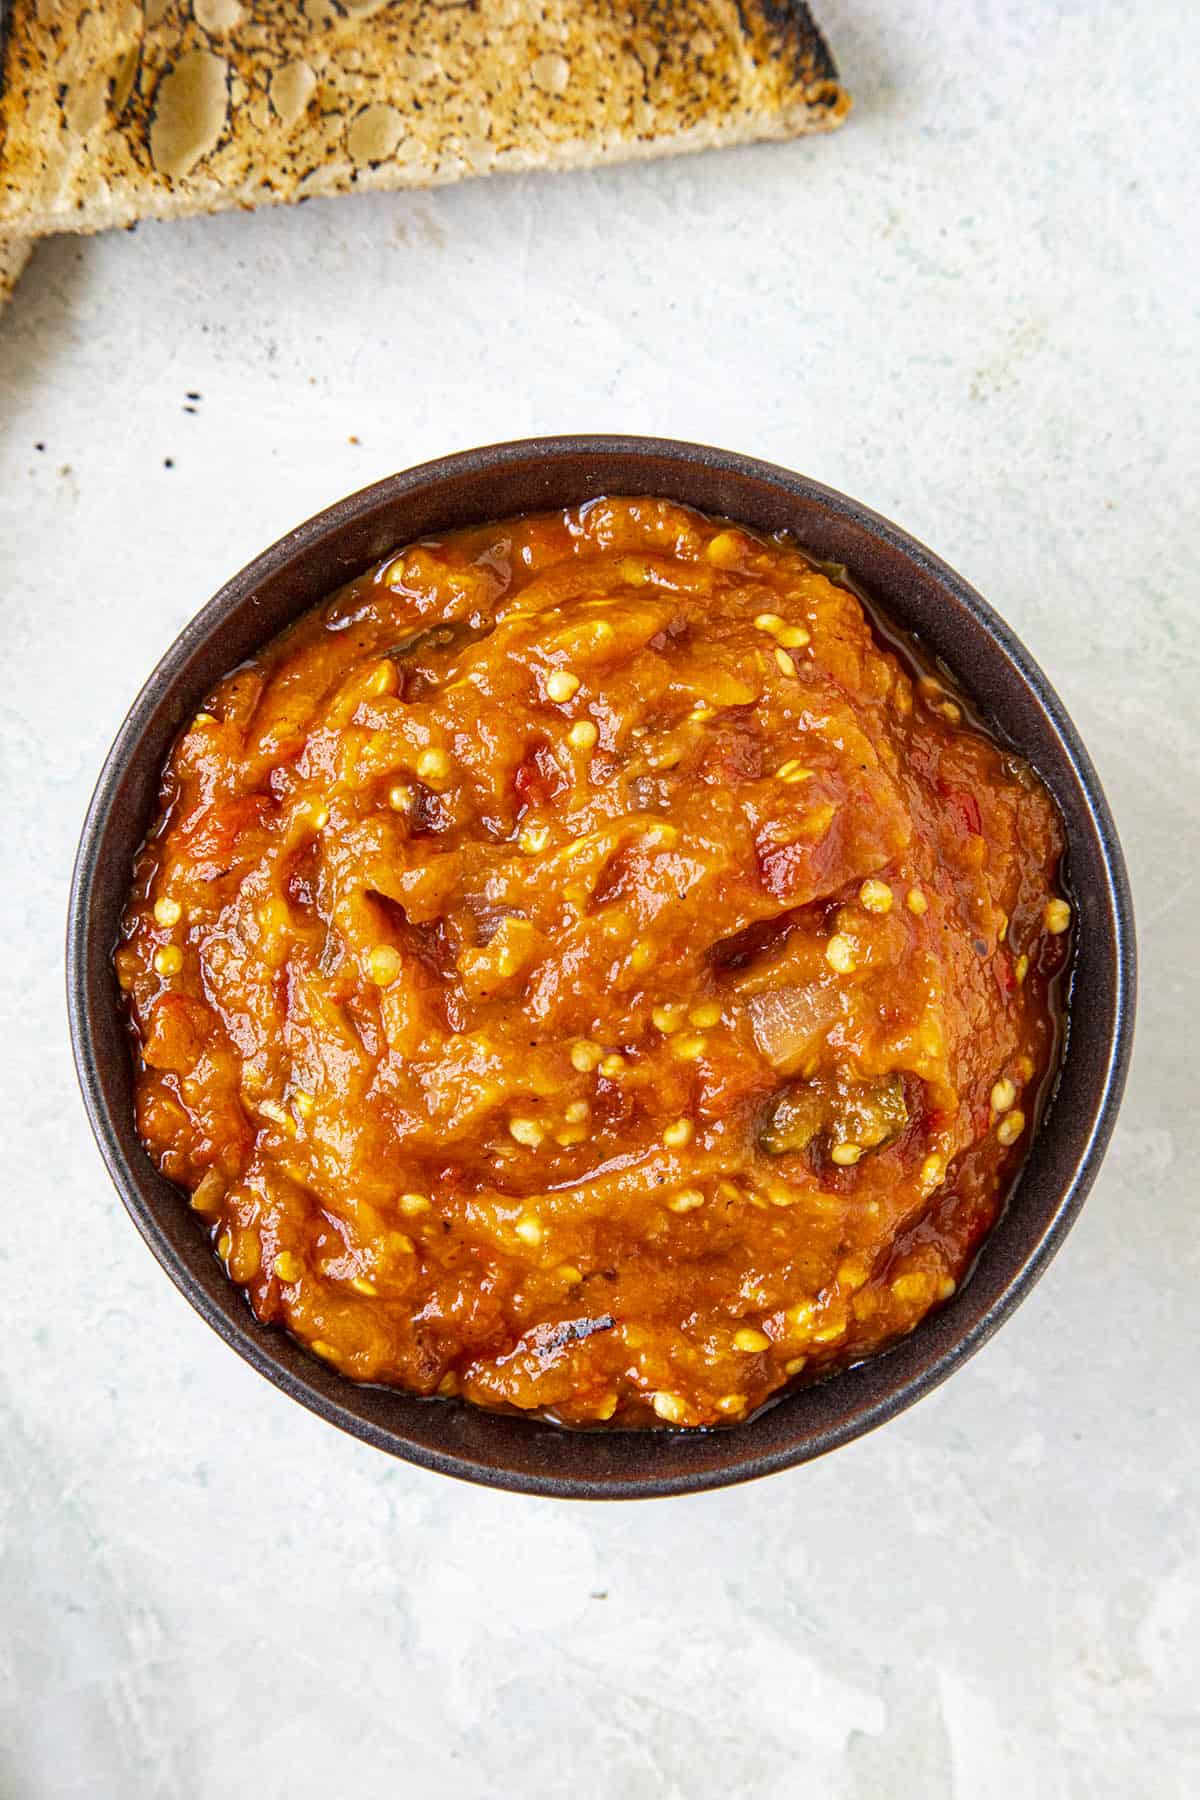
[{"left": 0, "top": 0, "right": 849, "bottom": 239}]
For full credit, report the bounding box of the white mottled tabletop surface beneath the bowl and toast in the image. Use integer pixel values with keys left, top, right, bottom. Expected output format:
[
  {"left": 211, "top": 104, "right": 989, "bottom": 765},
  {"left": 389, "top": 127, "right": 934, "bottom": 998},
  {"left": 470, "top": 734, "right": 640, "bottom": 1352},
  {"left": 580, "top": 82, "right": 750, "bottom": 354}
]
[{"left": 0, "top": 0, "right": 1200, "bottom": 1800}]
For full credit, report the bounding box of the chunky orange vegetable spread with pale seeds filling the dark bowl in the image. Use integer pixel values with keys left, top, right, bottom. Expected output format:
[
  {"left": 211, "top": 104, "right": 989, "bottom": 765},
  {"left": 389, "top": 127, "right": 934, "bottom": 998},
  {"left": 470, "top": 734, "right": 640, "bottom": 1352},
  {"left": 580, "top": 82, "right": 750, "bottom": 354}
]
[{"left": 117, "top": 499, "right": 1070, "bottom": 1426}]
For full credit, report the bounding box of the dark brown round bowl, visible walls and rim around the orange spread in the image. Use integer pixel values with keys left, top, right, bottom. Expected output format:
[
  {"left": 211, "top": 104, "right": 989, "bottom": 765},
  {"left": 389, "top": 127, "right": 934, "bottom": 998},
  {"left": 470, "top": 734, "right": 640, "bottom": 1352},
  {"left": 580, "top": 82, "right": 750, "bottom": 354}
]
[{"left": 67, "top": 437, "right": 1135, "bottom": 1499}]
